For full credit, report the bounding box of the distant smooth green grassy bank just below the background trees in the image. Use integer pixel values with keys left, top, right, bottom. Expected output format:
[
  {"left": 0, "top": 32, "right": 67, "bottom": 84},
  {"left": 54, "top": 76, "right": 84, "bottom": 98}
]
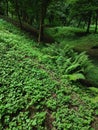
[{"left": 45, "top": 26, "right": 98, "bottom": 51}]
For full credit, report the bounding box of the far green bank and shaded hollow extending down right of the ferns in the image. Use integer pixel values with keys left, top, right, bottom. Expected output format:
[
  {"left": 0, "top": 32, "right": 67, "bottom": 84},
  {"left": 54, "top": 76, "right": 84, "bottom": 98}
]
[{"left": 45, "top": 27, "right": 98, "bottom": 84}]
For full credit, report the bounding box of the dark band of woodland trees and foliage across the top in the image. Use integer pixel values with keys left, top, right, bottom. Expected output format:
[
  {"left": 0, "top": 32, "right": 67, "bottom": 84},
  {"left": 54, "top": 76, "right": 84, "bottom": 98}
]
[{"left": 0, "top": 0, "right": 98, "bottom": 42}]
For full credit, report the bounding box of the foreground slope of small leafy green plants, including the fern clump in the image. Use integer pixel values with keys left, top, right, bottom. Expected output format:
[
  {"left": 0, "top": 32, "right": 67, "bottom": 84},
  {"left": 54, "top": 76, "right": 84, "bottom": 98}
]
[{"left": 0, "top": 20, "right": 98, "bottom": 130}]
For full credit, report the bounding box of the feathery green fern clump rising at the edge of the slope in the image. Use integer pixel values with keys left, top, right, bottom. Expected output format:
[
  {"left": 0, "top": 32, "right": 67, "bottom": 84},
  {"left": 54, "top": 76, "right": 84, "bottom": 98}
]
[{"left": 43, "top": 44, "right": 93, "bottom": 80}]
